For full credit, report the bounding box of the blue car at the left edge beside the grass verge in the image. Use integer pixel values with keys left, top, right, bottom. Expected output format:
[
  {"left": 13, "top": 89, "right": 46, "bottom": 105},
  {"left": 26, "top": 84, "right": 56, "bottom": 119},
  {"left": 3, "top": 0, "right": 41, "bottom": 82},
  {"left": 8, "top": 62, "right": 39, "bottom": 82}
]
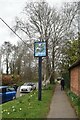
[{"left": 0, "top": 86, "right": 16, "bottom": 104}]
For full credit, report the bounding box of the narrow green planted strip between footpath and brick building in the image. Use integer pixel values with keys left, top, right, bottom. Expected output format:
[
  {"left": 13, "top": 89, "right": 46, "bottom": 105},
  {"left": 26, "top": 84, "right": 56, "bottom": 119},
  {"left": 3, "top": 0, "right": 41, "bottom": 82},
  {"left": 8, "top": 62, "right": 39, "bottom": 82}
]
[{"left": 67, "top": 91, "right": 80, "bottom": 118}]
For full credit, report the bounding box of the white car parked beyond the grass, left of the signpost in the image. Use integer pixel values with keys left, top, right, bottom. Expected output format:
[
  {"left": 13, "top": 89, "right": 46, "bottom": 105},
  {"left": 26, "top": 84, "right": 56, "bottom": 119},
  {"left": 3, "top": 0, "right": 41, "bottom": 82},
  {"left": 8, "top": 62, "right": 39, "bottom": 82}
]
[{"left": 20, "top": 83, "right": 36, "bottom": 92}]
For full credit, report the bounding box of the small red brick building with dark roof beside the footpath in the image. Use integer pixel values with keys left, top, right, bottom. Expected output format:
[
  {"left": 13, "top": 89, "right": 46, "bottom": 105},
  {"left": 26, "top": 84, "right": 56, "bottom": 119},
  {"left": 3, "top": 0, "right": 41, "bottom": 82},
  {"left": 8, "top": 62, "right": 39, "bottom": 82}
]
[{"left": 69, "top": 60, "right": 80, "bottom": 96}]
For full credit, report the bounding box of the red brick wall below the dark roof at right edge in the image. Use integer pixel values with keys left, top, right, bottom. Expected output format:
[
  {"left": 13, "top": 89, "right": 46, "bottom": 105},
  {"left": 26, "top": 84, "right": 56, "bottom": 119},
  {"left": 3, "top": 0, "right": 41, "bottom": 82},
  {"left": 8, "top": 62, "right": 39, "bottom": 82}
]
[{"left": 70, "top": 66, "right": 80, "bottom": 95}]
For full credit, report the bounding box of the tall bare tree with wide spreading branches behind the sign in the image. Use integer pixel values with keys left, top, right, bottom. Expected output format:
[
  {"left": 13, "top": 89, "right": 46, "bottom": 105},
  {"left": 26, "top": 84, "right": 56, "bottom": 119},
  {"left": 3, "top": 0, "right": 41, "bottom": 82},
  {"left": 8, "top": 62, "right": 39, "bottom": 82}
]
[{"left": 15, "top": 0, "right": 77, "bottom": 81}]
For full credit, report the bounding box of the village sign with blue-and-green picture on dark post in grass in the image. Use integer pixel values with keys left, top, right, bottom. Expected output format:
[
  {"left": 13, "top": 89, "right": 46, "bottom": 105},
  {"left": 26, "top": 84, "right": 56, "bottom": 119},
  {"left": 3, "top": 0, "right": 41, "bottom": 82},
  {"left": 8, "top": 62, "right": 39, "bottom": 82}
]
[{"left": 34, "top": 41, "right": 46, "bottom": 101}]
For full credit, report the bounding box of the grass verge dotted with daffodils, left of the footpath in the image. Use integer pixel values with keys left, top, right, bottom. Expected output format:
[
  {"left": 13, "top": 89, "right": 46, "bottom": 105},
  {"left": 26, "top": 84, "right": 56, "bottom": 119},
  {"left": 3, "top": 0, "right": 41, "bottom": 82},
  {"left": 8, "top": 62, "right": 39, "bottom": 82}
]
[{"left": 1, "top": 85, "right": 54, "bottom": 120}]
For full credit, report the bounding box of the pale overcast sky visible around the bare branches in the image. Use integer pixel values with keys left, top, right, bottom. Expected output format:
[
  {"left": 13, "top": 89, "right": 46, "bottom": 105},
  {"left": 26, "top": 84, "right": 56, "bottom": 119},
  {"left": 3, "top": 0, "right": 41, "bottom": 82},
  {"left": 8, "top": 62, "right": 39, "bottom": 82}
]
[{"left": 0, "top": 0, "right": 78, "bottom": 46}]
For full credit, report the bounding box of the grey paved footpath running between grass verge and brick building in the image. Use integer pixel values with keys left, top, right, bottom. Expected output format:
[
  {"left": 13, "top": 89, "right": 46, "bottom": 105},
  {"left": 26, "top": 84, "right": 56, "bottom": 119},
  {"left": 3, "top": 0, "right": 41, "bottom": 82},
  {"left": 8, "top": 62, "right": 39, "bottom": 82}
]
[{"left": 47, "top": 85, "right": 77, "bottom": 120}]
